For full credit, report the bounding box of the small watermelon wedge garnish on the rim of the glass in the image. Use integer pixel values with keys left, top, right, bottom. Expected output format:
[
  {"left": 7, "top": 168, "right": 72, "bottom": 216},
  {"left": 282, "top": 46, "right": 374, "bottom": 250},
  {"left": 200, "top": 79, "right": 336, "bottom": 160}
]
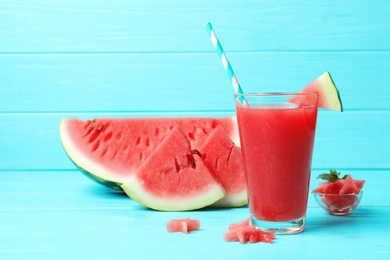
[{"left": 301, "top": 72, "right": 343, "bottom": 112}]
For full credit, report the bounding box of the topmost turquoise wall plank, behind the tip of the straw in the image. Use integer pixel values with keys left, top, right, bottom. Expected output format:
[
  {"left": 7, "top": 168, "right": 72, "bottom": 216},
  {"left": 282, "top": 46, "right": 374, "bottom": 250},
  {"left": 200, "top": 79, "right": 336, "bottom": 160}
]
[{"left": 0, "top": 0, "right": 390, "bottom": 53}]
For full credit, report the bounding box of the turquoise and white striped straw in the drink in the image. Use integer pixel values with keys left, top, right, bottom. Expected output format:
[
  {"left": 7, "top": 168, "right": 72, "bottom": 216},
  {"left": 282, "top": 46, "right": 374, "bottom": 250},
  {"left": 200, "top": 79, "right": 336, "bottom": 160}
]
[{"left": 206, "top": 23, "right": 246, "bottom": 103}]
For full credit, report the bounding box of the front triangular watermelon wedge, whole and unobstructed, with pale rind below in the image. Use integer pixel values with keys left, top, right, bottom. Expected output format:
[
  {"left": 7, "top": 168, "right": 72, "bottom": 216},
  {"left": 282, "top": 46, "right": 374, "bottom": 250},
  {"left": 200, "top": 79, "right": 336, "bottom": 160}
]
[{"left": 122, "top": 127, "right": 225, "bottom": 211}]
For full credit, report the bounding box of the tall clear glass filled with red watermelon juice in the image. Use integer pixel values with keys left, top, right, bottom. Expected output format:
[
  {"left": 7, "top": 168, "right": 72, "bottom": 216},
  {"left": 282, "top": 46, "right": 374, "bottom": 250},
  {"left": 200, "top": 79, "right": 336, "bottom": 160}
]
[{"left": 235, "top": 93, "right": 317, "bottom": 234}]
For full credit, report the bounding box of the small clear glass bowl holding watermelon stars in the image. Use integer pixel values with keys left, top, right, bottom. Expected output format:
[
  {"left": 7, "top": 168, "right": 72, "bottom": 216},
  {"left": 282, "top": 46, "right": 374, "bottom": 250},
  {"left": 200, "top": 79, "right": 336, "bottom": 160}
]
[{"left": 314, "top": 191, "right": 363, "bottom": 216}]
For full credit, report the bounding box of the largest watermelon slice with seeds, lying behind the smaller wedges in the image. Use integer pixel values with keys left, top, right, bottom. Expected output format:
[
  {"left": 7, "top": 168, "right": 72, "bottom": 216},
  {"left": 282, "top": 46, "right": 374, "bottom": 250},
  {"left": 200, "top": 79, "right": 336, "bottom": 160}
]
[{"left": 59, "top": 117, "right": 239, "bottom": 190}]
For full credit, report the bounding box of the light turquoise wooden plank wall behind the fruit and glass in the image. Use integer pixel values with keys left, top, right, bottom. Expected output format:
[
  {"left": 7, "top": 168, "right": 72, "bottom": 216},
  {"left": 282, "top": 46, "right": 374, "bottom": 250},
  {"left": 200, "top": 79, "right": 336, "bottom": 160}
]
[{"left": 0, "top": 0, "right": 390, "bottom": 174}]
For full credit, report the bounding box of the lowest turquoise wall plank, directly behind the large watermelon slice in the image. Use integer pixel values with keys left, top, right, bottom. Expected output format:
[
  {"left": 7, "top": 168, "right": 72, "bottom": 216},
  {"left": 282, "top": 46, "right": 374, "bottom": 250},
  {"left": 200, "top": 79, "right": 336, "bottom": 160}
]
[{"left": 0, "top": 111, "right": 390, "bottom": 170}]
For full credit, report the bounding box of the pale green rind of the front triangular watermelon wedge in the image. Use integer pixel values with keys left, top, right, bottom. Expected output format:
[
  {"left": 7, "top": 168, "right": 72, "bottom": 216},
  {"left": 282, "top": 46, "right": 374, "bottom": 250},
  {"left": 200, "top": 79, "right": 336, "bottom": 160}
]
[{"left": 121, "top": 175, "right": 225, "bottom": 211}]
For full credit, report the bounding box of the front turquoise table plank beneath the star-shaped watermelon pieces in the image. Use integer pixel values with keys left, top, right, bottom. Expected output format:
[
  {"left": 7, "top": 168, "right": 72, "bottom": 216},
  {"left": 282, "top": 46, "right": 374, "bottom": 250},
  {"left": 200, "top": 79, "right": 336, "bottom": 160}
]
[{"left": 0, "top": 207, "right": 390, "bottom": 259}]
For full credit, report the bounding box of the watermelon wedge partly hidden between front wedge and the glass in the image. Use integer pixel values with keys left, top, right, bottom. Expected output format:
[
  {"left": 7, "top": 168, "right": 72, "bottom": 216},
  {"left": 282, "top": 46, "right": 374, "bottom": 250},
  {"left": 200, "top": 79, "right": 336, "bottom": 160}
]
[{"left": 199, "top": 127, "right": 248, "bottom": 207}]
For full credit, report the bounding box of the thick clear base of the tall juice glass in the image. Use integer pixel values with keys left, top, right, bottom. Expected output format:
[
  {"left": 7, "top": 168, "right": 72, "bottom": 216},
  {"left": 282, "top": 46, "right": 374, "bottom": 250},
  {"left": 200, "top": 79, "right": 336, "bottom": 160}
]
[{"left": 249, "top": 215, "right": 306, "bottom": 234}]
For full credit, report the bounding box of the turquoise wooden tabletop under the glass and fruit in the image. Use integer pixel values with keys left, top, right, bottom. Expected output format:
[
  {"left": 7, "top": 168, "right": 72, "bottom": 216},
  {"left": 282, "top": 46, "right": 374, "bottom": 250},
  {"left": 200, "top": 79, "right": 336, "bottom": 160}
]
[{"left": 0, "top": 171, "right": 390, "bottom": 259}]
